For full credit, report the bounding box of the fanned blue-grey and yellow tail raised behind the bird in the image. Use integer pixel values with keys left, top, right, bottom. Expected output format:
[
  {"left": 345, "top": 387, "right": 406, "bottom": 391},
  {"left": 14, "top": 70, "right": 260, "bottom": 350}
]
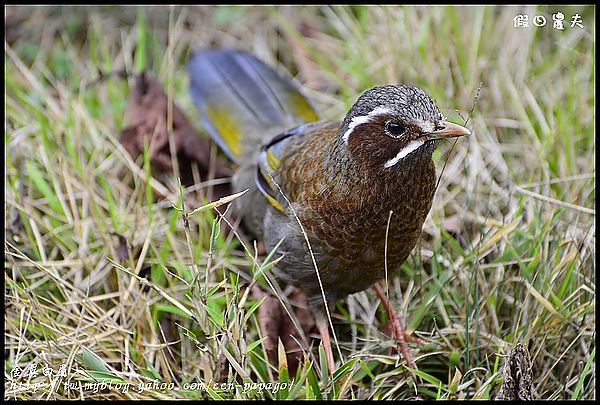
[{"left": 187, "top": 49, "right": 318, "bottom": 163}]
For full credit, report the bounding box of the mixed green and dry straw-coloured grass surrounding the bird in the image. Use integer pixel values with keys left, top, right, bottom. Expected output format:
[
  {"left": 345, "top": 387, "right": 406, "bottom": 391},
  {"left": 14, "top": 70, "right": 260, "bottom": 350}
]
[{"left": 4, "top": 6, "right": 596, "bottom": 399}]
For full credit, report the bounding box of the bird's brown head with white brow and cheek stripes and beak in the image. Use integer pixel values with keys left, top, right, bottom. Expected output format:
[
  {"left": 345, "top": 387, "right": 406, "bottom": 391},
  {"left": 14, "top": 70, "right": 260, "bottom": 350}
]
[{"left": 339, "top": 85, "right": 471, "bottom": 171}]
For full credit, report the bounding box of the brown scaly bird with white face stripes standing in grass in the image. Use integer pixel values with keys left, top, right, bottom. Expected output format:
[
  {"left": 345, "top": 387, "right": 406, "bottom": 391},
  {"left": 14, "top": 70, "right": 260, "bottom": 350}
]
[{"left": 187, "top": 48, "right": 471, "bottom": 372}]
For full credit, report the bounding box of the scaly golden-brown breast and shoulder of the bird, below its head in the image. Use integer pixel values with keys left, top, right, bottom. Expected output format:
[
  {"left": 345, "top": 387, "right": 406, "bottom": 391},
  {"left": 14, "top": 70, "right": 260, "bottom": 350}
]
[{"left": 277, "top": 119, "right": 435, "bottom": 296}]
